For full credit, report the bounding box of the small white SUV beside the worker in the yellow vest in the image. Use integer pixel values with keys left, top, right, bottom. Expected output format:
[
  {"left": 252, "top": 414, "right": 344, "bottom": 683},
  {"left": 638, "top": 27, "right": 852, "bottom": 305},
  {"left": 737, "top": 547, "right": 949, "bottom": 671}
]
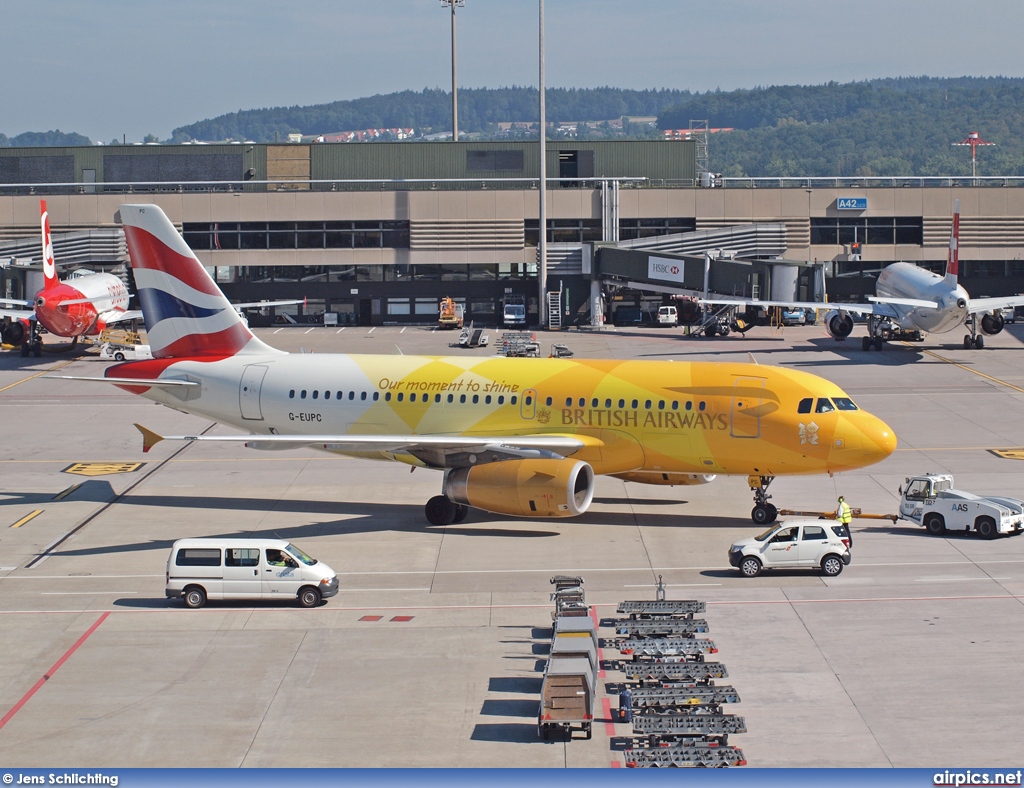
[{"left": 729, "top": 519, "right": 851, "bottom": 577}]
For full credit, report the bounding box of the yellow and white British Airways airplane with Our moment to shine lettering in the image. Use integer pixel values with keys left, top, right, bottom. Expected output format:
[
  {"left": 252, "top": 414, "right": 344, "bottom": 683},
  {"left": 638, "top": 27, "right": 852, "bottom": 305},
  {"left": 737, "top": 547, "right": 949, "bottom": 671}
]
[{"left": 59, "top": 205, "right": 896, "bottom": 525}]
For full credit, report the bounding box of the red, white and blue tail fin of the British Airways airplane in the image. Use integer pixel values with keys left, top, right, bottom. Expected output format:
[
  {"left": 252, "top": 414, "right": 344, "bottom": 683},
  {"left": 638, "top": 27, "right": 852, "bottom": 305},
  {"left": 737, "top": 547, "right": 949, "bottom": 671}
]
[{"left": 119, "top": 205, "right": 278, "bottom": 360}]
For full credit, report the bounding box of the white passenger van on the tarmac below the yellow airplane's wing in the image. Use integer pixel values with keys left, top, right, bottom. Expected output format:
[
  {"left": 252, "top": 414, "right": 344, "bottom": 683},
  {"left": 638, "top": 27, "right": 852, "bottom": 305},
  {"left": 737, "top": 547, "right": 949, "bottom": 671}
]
[{"left": 164, "top": 538, "right": 338, "bottom": 608}]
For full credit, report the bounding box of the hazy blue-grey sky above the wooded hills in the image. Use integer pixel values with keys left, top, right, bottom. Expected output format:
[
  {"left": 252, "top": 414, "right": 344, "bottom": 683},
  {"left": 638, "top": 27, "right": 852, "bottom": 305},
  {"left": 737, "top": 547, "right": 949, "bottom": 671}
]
[{"left": 6, "top": 0, "right": 1024, "bottom": 142}]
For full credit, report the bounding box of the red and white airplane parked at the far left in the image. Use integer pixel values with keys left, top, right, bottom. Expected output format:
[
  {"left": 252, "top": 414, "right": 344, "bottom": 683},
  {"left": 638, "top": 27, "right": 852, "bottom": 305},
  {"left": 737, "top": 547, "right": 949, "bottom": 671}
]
[{"left": 0, "top": 200, "right": 142, "bottom": 356}]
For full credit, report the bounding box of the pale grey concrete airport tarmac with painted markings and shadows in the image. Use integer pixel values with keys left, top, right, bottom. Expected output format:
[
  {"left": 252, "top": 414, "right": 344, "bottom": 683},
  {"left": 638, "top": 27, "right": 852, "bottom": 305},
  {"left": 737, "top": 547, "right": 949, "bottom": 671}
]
[{"left": 0, "top": 325, "right": 1024, "bottom": 768}]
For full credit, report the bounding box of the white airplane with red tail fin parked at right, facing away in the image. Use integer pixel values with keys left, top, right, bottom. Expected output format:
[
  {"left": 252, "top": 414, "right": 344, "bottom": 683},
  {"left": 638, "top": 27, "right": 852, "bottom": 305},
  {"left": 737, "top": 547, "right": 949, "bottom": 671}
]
[{"left": 707, "top": 200, "right": 1024, "bottom": 350}]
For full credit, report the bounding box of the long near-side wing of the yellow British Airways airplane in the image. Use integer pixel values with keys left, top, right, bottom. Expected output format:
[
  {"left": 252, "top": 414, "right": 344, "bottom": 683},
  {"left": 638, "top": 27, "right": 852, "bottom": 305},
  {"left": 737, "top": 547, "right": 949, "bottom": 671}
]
[{"left": 132, "top": 423, "right": 594, "bottom": 468}]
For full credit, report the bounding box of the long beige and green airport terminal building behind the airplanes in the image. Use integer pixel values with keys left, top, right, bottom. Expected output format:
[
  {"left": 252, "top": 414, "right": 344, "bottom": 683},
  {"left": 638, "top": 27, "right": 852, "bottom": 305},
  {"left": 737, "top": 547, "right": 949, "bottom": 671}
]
[{"left": 0, "top": 139, "right": 1024, "bottom": 324}]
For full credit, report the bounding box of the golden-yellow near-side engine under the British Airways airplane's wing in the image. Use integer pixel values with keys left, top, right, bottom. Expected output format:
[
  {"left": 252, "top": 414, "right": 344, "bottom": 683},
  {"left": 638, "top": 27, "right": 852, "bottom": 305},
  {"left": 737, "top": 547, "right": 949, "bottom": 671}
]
[{"left": 444, "top": 459, "right": 594, "bottom": 517}]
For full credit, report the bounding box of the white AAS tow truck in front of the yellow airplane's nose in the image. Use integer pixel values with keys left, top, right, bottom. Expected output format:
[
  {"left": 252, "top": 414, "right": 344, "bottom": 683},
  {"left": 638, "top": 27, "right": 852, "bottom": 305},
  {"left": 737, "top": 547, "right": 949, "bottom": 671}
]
[{"left": 899, "top": 474, "right": 1024, "bottom": 539}]
